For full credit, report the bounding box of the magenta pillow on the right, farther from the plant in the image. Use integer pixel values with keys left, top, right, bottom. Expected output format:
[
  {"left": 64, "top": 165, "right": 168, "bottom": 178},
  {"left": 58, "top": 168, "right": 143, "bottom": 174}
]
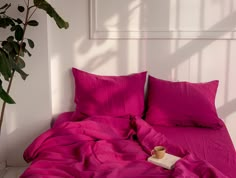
[{"left": 146, "top": 76, "right": 222, "bottom": 128}]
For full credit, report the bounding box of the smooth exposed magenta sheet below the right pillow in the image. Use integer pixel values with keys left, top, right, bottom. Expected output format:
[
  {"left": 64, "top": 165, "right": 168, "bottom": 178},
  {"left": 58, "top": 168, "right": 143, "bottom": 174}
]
[{"left": 154, "top": 126, "right": 236, "bottom": 178}]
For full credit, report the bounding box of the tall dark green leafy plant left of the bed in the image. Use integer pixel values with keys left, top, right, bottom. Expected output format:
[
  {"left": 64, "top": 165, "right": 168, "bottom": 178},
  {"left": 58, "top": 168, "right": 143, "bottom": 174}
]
[{"left": 0, "top": 0, "right": 69, "bottom": 130}]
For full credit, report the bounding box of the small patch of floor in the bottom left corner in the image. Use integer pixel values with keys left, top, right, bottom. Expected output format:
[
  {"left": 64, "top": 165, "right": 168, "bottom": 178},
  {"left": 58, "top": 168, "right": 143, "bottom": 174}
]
[{"left": 0, "top": 167, "right": 26, "bottom": 178}]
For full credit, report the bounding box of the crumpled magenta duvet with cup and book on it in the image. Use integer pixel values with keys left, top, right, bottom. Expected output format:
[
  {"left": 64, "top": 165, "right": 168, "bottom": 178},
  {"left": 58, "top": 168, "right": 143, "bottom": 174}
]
[{"left": 21, "top": 116, "right": 226, "bottom": 178}]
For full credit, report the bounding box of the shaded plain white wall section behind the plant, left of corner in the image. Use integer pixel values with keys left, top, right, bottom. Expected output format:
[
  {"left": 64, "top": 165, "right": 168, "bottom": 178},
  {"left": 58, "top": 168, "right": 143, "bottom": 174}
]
[{"left": 0, "top": 1, "right": 52, "bottom": 166}]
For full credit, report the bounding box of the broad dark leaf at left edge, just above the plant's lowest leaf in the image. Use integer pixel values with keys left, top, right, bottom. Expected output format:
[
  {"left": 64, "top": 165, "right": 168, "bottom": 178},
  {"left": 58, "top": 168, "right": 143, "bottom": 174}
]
[{"left": 0, "top": 49, "right": 12, "bottom": 81}]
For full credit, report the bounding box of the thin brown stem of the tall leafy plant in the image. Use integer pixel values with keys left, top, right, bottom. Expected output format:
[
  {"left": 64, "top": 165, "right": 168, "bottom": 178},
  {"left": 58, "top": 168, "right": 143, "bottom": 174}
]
[{"left": 0, "top": 0, "right": 31, "bottom": 132}]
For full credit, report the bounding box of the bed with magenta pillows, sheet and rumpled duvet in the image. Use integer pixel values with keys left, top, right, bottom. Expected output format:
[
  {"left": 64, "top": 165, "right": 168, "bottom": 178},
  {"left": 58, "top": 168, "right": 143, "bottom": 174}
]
[{"left": 21, "top": 68, "right": 236, "bottom": 178}]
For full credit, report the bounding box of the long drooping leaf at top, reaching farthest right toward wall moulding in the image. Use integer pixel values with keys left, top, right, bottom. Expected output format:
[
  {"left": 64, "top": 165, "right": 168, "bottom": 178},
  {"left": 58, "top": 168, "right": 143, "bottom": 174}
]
[{"left": 34, "top": 0, "right": 69, "bottom": 29}]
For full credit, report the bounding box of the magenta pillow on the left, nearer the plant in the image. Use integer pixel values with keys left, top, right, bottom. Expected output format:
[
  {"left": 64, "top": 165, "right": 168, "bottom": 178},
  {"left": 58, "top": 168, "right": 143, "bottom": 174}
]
[{"left": 72, "top": 68, "right": 147, "bottom": 116}]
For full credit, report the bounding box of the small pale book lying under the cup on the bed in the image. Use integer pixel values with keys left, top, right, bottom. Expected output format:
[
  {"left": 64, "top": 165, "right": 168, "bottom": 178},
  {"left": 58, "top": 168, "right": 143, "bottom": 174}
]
[{"left": 148, "top": 153, "right": 181, "bottom": 169}]
